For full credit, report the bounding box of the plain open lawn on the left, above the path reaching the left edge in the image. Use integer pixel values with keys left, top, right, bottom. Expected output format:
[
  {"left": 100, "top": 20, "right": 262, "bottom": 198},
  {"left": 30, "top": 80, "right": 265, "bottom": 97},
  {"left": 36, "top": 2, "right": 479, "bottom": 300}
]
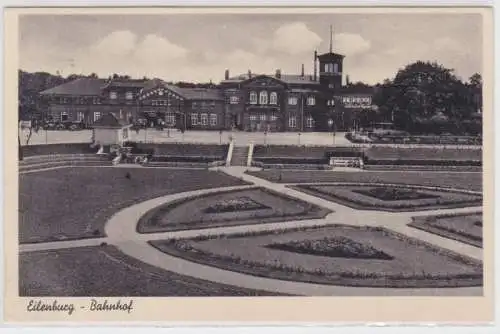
[{"left": 19, "top": 167, "right": 248, "bottom": 243}]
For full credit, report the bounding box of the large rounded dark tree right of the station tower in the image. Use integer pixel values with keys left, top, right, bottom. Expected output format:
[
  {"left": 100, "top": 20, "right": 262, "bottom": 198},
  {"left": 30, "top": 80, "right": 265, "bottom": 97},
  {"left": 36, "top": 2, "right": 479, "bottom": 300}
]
[{"left": 373, "top": 61, "right": 474, "bottom": 131}]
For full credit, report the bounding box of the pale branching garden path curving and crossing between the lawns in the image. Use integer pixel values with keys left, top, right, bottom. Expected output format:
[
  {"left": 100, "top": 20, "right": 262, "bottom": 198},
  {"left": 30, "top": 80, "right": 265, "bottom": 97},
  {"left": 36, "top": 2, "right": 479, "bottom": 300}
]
[{"left": 20, "top": 166, "right": 483, "bottom": 296}]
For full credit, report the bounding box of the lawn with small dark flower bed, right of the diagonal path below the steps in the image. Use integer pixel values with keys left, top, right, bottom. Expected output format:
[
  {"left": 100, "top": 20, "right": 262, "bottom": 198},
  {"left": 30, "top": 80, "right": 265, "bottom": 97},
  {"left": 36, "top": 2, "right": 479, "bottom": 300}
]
[{"left": 291, "top": 184, "right": 482, "bottom": 212}]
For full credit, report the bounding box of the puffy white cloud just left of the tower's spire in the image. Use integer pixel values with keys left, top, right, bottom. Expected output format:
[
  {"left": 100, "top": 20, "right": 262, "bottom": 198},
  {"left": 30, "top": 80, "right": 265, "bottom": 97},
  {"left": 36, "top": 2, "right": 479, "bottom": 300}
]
[{"left": 270, "top": 22, "right": 322, "bottom": 55}]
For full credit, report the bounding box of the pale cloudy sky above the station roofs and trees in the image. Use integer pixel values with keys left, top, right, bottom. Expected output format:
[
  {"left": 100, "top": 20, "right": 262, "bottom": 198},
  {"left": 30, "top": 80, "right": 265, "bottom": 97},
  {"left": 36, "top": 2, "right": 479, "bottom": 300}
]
[{"left": 19, "top": 13, "right": 483, "bottom": 84}]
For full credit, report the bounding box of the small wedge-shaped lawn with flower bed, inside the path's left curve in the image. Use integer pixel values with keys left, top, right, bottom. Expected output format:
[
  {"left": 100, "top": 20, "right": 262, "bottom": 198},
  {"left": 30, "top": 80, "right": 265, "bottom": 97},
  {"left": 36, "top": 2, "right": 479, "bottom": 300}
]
[{"left": 137, "top": 188, "right": 331, "bottom": 233}]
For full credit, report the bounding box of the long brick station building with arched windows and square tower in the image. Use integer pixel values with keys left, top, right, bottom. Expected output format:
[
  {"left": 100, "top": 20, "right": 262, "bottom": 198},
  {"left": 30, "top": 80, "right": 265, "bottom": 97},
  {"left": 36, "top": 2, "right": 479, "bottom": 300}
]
[{"left": 39, "top": 42, "right": 373, "bottom": 132}]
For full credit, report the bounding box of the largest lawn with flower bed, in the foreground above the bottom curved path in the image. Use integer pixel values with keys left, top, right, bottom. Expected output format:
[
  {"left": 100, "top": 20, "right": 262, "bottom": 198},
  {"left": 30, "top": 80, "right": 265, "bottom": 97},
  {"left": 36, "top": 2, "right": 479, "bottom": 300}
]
[{"left": 151, "top": 225, "right": 483, "bottom": 288}]
